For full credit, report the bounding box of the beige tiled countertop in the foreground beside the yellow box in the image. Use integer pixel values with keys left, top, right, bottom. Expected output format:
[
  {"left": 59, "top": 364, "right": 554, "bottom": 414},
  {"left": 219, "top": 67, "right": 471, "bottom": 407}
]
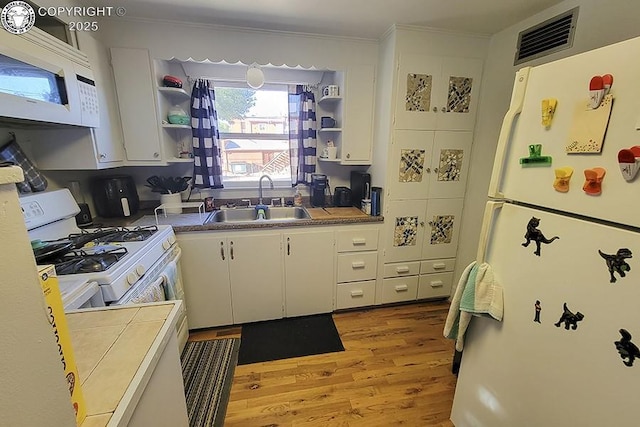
[{"left": 66, "top": 301, "right": 182, "bottom": 427}]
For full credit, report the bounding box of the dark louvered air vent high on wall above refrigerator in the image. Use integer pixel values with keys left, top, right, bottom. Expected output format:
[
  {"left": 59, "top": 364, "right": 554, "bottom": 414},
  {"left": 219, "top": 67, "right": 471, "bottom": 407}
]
[{"left": 513, "top": 7, "right": 578, "bottom": 65}]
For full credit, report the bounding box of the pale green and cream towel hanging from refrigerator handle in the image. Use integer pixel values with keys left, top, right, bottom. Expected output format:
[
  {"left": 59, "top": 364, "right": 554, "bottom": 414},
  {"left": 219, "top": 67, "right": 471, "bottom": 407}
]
[{"left": 444, "top": 261, "right": 504, "bottom": 351}]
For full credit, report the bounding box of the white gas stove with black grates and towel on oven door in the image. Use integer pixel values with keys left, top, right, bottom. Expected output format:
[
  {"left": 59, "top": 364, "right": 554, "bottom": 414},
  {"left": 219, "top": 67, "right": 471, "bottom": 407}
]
[{"left": 20, "top": 189, "right": 189, "bottom": 351}]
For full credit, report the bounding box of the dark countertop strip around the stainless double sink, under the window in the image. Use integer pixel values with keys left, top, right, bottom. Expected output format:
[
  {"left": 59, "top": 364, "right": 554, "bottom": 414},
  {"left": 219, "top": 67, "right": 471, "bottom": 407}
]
[{"left": 131, "top": 207, "right": 384, "bottom": 233}]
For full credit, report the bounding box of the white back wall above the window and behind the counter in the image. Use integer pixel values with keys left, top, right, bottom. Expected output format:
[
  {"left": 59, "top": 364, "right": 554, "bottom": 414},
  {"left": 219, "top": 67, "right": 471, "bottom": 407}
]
[{"left": 46, "top": 18, "right": 378, "bottom": 200}]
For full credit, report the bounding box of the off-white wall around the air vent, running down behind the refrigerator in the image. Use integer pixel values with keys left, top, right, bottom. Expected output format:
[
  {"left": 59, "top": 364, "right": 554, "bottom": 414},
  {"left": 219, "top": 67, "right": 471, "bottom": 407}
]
[{"left": 455, "top": 0, "right": 640, "bottom": 288}]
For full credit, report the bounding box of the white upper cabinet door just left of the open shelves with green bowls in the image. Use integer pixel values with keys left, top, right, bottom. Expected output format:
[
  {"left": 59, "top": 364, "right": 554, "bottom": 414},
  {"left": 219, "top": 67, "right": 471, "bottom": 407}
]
[{"left": 111, "top": 48, "right": 163, "bottom": 165}]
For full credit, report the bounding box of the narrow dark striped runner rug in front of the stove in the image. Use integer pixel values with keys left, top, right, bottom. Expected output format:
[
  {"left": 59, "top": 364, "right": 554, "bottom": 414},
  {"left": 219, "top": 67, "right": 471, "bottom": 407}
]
[{"left": 181, "top": 338, "right": 240, "bottom": 427}]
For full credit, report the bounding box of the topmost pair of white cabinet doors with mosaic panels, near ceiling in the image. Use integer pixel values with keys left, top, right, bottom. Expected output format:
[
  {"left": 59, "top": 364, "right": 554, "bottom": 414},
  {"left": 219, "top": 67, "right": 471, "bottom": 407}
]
[{"left": 394, "top": 54, "right": 482, "bottom": 130}]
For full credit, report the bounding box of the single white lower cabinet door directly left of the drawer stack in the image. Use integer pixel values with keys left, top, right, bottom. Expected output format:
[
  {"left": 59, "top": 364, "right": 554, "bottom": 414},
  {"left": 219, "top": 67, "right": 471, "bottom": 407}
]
[{"left": 282, "top": 230, "right": 334, "bottom": 317}]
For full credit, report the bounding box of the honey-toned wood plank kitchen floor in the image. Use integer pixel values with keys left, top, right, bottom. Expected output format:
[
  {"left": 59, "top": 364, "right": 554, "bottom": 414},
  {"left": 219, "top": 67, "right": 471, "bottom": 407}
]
[{"left": 190, "top": 301, "right": 456, "bottom": 427}]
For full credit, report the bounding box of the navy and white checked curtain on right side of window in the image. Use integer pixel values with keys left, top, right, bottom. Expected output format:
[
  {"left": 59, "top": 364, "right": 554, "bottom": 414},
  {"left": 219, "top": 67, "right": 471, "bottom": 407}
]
[{"left": 289, "top": 85, "right": 317, "bottom": 186}]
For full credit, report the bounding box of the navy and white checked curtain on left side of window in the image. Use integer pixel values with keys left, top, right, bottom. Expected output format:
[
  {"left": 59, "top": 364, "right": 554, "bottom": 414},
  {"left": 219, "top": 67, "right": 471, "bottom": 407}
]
[{"left": 191, "top": 79, "right": 223, "bottom": 188}]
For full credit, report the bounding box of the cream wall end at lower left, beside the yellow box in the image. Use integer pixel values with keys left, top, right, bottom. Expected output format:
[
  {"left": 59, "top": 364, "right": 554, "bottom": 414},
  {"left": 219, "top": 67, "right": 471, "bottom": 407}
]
[{"left": 0, "top": 176, "right": 75, "bottom": 426}]
